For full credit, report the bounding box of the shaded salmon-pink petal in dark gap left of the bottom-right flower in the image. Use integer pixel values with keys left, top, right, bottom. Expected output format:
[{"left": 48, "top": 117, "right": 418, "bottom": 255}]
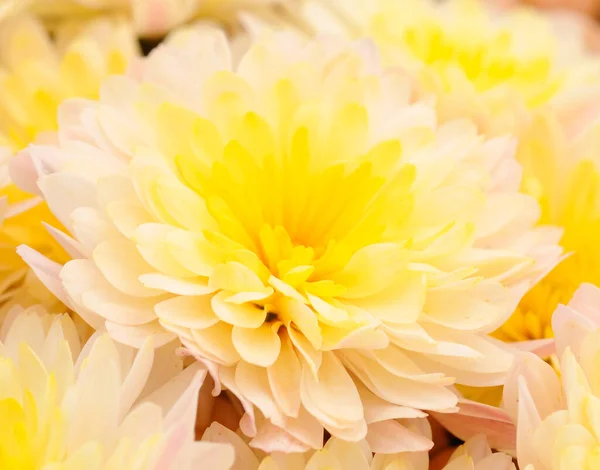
[{"left": 431, "top": 399, "right": 516, "bottom": 451}]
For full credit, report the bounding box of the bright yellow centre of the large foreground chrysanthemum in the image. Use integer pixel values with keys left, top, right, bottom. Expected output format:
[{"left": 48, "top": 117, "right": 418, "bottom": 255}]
[{"left": 148, "top": 72, "right": 419, "bottom": 334}]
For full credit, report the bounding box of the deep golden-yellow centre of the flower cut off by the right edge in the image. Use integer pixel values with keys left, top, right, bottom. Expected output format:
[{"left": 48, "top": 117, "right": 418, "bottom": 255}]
[{"left": 496, "top": 160, "right": 600, "bottom": 341}]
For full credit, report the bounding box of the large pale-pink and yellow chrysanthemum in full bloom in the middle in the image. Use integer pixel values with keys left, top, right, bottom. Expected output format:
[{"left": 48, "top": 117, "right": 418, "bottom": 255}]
[{"left": 13, "top": 30, "right": 559, "bottom": 452}]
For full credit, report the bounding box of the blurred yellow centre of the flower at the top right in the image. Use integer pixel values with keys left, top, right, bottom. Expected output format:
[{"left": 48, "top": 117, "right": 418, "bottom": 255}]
[{"left": 369, "top": 2, "right": 561, "bottom": 107}]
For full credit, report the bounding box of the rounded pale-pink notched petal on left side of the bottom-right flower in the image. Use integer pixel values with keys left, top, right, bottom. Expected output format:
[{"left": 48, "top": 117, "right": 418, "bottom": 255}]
[{"left": 503, "top": 353, "right": 561, "bottom": 422}]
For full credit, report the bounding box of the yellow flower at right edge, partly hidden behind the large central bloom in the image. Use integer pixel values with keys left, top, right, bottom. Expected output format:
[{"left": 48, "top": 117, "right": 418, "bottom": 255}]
[{"left": 497, "top": 104, "right": 600, "bottom": 350}]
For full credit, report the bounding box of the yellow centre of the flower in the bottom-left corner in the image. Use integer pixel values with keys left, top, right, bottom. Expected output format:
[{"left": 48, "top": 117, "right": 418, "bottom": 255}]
[{"left": 0, "top": 344, "right": 65, "bottom": 470}]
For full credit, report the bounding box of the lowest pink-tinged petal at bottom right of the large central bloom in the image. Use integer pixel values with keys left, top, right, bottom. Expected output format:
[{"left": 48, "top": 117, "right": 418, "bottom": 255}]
[{"left": 366, "top": 420, "right": 433, "bottom": 454}]
